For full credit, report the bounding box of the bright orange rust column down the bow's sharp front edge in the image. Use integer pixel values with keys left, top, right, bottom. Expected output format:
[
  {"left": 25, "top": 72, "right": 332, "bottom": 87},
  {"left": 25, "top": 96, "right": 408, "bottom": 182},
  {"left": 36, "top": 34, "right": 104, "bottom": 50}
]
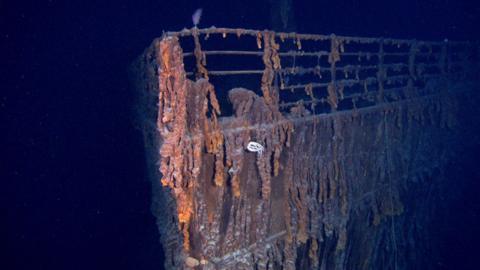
[{"left": 156, "top": 38, "right": 193, "bottom": 250}]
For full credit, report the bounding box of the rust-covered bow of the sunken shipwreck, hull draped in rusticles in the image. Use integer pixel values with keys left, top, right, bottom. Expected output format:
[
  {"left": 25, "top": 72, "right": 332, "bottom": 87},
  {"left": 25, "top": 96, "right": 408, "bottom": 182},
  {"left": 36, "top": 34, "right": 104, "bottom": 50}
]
[{"left": 132, "top": 28, "right": 480, "bottom": 269}]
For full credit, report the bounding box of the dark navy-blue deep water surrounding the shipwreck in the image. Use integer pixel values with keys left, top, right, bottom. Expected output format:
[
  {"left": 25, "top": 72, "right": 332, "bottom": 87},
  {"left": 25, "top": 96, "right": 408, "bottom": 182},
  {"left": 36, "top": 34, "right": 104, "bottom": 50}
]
[{"left": 0, "top": 0, "right": 480, "bottom": 269}]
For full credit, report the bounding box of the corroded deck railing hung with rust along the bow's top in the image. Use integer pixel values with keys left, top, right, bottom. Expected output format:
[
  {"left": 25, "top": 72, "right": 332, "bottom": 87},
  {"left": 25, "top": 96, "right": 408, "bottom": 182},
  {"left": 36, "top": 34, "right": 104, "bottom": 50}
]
[{"left": 164, "top": 27, "right": 478, "bottom": 115}]
